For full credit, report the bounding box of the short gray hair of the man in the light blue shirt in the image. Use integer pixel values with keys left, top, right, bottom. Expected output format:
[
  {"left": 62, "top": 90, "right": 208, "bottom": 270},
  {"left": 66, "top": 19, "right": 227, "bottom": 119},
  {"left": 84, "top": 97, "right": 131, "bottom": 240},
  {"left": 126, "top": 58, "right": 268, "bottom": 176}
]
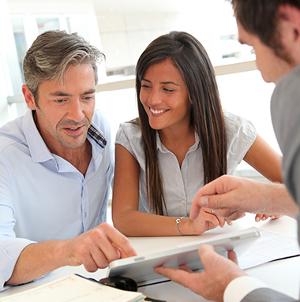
[{"left": 23, "top": 31, "right": 104, "bottom": 98}]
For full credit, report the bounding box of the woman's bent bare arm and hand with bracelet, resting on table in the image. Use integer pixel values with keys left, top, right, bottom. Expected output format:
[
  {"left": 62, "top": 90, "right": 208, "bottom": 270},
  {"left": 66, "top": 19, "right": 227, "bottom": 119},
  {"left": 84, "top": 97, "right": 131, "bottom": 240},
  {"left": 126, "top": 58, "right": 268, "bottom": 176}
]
[{"left": 112, "top": 144, "right": 224, "bottom": 236}]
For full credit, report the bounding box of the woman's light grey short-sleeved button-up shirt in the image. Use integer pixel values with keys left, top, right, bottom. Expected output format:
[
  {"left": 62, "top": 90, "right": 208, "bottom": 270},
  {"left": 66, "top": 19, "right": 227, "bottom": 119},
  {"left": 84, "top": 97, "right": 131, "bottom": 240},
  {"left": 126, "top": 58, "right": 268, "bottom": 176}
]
[{"left": 116, "top": 112, "right": 256, "bottom": 217}]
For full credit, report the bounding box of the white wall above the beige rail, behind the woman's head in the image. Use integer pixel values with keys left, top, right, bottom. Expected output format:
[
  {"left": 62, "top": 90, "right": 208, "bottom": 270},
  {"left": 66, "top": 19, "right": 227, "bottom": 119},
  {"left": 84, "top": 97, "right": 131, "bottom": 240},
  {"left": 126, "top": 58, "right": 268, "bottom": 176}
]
[{"left": 94, "top": 0, "right": 241, "bottom": 69}]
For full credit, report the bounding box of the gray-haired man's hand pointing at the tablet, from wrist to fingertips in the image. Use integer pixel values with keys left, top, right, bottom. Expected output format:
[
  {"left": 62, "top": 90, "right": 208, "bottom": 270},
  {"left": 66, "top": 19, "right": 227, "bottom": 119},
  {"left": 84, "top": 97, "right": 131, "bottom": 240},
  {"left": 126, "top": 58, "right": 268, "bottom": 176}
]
[{"left": 64, "top": 223, "right": 136, "bottom": 272}]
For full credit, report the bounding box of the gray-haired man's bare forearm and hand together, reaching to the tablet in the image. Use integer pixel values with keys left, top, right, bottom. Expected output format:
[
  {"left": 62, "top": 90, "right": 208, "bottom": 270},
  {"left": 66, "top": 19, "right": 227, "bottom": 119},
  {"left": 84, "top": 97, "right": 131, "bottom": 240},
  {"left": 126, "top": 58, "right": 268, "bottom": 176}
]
[{"left": 7, "top": 223, "right": 136, "bottom": 284}]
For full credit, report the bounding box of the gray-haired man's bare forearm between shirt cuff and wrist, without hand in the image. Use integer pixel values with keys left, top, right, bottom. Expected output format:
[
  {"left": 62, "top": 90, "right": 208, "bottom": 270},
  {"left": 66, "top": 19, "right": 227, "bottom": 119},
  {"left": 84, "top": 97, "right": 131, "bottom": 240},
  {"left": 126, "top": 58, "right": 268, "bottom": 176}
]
[{"left": 7, "top": 240, "right": 68, "bottom": 285}]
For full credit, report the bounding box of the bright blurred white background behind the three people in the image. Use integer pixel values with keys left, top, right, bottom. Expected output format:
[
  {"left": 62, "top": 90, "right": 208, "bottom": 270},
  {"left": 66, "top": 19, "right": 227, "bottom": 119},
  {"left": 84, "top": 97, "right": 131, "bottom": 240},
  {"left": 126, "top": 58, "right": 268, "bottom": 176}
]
[{"left": 0, "top": 0, "right": 279, "bottom": 177}]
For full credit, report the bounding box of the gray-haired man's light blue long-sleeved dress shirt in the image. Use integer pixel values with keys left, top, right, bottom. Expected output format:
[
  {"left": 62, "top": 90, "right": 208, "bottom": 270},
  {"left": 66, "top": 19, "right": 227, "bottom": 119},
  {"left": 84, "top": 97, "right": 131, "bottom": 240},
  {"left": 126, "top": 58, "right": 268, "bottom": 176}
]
[{"left": 0, "top": 111, "right": 113, "bottom": 290}]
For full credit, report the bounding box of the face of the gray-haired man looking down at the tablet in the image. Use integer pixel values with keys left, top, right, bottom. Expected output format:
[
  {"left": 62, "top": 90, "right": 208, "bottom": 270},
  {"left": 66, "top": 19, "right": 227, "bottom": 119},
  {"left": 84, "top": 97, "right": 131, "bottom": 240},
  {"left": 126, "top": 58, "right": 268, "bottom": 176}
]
[{"left": 29, "top": 64, "right": 95, "bottom": 152}]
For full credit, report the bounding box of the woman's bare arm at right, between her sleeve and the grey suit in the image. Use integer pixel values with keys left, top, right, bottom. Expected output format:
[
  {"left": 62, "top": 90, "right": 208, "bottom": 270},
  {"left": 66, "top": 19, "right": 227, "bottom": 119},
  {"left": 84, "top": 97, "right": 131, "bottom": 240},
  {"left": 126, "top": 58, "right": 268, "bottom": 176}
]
[{"left": 244, "top": 136, "right": 282, "bottom": 183}]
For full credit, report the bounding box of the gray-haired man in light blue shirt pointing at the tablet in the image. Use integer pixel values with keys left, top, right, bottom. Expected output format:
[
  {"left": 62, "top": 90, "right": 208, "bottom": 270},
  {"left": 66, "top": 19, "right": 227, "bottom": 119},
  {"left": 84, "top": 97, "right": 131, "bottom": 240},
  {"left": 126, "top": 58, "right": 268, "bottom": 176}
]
[{"left": 0, "top": 31, "right": 135, "bottom": 289}]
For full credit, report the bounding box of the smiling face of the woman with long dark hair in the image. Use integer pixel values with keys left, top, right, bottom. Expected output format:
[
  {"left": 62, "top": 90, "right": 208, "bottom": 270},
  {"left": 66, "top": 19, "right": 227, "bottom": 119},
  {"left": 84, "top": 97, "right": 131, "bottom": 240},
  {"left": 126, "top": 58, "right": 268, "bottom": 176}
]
[{"left": 139, "top": 58, "right": 190, "bottom": 130}]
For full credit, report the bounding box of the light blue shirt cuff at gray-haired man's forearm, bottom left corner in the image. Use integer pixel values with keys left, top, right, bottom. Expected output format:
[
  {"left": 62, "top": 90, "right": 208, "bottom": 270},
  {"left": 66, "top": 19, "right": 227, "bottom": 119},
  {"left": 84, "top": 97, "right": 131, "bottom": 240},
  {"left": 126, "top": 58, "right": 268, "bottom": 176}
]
[{"left": 0, "top": 238, "right": 33, "bottom": 292}]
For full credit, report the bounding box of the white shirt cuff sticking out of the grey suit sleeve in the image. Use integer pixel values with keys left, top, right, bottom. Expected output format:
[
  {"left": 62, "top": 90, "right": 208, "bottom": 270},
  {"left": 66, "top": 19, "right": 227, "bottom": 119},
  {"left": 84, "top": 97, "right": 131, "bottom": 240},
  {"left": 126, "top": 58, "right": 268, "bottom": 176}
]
[{"left": 224, "top": 276, "right": 266, "bottom": 302}]
